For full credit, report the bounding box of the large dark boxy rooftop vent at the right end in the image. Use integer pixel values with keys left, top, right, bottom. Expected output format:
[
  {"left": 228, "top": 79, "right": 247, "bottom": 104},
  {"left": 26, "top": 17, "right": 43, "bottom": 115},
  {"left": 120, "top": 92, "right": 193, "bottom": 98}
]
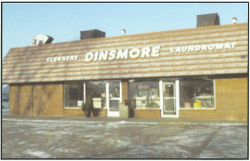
[{"left": 197, "top": 13, "right": 220, "bottom": 27}]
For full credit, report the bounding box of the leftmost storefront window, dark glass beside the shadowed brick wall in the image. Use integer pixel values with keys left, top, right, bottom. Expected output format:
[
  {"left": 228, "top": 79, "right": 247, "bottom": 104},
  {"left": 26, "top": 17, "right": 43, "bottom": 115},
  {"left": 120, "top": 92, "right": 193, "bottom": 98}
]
[{"left": 64, "top": 83, "right": 83, "bottom": 108}]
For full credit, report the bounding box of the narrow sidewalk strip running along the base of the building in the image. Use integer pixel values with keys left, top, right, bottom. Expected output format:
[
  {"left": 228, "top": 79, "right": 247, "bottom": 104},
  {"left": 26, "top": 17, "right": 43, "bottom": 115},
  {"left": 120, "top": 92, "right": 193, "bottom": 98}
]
[{"left": 2, "top": 114, "right": 248, "bottom": 126}]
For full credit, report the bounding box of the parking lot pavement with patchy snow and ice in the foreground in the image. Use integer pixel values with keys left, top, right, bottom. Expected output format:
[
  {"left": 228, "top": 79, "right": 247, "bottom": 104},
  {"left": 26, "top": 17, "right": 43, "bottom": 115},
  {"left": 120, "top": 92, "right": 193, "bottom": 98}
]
[{"left": 2, "top": 116, "right": 248, "bottom": 159}]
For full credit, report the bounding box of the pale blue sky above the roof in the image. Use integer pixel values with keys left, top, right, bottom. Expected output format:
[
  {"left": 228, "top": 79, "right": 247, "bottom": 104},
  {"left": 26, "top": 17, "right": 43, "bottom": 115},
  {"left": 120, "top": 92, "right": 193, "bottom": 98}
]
[{"left": 2, "top": 2, "right": 248, "bottom": 57}]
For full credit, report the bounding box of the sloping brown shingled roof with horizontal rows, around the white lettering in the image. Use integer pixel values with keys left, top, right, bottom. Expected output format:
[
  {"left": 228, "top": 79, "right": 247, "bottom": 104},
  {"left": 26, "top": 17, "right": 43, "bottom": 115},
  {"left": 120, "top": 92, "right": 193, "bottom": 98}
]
[{"left": 2, "top": 23, "right": 248, "bottom": 84}]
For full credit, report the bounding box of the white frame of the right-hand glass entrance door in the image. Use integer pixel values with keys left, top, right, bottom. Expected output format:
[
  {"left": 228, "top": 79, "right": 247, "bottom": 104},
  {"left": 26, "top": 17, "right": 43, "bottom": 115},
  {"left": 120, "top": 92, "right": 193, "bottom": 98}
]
[{"left": 159, "top": 80, "right": 180, "bottom": 117}]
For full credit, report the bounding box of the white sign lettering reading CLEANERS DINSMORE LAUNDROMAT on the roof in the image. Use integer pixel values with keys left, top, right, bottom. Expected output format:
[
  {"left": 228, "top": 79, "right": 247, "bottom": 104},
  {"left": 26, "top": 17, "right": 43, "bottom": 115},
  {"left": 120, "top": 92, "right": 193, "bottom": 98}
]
[{"left": 47, "top": 42, "right": 236, "bottom": 62}]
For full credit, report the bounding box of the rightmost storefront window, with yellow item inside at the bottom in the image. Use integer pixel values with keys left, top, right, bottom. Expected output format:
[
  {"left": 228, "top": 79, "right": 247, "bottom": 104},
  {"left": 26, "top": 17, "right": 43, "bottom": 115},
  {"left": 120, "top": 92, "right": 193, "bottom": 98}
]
[{"left": 180, "top": 79, "right": 214, "bottom": 108}]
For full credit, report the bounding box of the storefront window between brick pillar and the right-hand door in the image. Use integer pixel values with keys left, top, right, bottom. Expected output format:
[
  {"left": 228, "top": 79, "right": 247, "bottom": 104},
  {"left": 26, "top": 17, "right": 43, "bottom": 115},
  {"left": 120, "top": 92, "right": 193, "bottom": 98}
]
[{"left": 129, "top": 80, "right": 160, "bottom": 109}]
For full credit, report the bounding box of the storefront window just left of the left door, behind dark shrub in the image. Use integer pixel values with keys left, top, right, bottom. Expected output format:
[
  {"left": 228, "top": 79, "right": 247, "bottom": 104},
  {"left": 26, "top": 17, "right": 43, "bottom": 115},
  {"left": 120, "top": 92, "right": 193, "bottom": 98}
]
[{"left": 86, "top": 81, "right": 107, "bottom": 108}]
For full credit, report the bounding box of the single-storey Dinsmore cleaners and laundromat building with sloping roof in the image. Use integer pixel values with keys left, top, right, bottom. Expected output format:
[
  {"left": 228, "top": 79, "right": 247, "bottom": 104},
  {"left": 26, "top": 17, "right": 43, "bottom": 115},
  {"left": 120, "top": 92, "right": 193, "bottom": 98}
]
[{"left": 2, "top": 14, "right": 248, "bottom": 120}]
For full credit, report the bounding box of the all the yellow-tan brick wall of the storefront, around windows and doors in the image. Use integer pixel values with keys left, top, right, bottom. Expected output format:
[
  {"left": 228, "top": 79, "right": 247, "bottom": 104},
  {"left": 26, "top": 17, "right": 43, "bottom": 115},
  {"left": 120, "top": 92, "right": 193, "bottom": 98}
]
[{"left": 10, "top": 78, "right": 248, "bottom": 120}]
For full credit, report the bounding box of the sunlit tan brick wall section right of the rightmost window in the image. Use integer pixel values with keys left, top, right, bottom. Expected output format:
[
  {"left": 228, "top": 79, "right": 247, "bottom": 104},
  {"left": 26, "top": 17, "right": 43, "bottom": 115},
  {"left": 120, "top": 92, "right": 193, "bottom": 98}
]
[{"left": 216, "top": 78, "right": 248, "bottom": 120}]
